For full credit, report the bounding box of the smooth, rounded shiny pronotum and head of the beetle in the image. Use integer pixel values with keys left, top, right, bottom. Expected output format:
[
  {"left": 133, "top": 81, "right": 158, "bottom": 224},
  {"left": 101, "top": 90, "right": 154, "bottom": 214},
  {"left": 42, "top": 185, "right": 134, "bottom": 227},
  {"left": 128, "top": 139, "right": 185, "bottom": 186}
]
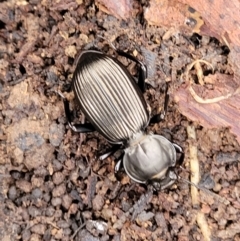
[{"left": 123, "top": 135, "right": 177, "bottom": 189}]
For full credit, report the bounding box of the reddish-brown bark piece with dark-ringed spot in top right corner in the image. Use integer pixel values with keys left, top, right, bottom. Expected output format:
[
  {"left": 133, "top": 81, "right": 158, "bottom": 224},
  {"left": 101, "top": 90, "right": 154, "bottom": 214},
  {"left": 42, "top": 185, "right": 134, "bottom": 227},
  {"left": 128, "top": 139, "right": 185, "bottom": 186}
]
[{"left": 144, "top": 0, "right": 240, "bottom": 83}]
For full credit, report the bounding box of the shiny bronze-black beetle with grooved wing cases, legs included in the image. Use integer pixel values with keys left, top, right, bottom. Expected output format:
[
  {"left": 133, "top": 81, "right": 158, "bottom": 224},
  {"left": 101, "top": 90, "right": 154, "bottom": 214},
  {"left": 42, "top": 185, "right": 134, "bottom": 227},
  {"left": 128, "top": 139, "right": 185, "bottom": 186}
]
[{"left": 60, "top": 49, "right": 184, "bottom": 190}]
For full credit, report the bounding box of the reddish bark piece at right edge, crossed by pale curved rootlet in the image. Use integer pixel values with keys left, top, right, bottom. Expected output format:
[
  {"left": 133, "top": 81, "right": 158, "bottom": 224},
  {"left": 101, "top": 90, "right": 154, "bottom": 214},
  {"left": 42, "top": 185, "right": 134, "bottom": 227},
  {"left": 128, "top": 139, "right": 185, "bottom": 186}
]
[{"left": 174, "top": 76, "right": 240, "bottom": 143}]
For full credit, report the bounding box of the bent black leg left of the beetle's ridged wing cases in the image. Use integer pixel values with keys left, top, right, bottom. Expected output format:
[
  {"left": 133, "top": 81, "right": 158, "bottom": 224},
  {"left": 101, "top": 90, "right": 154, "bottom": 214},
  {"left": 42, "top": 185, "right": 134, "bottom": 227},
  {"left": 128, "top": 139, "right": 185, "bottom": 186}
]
[{"left": 57, "top": 91, "right": 95, "bottom": 133}]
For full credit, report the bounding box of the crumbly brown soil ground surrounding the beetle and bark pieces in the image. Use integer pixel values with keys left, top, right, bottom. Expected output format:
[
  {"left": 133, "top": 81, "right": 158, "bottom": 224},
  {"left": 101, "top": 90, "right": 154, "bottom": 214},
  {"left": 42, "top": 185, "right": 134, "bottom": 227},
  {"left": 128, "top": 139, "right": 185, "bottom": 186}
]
[{"left": 0, "top": 0, "right": 240, "bottom": 241}]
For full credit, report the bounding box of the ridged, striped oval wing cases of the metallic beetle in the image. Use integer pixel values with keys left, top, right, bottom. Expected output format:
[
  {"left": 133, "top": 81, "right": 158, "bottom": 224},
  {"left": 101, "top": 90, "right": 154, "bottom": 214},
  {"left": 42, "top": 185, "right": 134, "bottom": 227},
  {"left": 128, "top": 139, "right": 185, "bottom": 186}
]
[{"left": 72, "top": 51, "right": 149, "bottom": 144}]
